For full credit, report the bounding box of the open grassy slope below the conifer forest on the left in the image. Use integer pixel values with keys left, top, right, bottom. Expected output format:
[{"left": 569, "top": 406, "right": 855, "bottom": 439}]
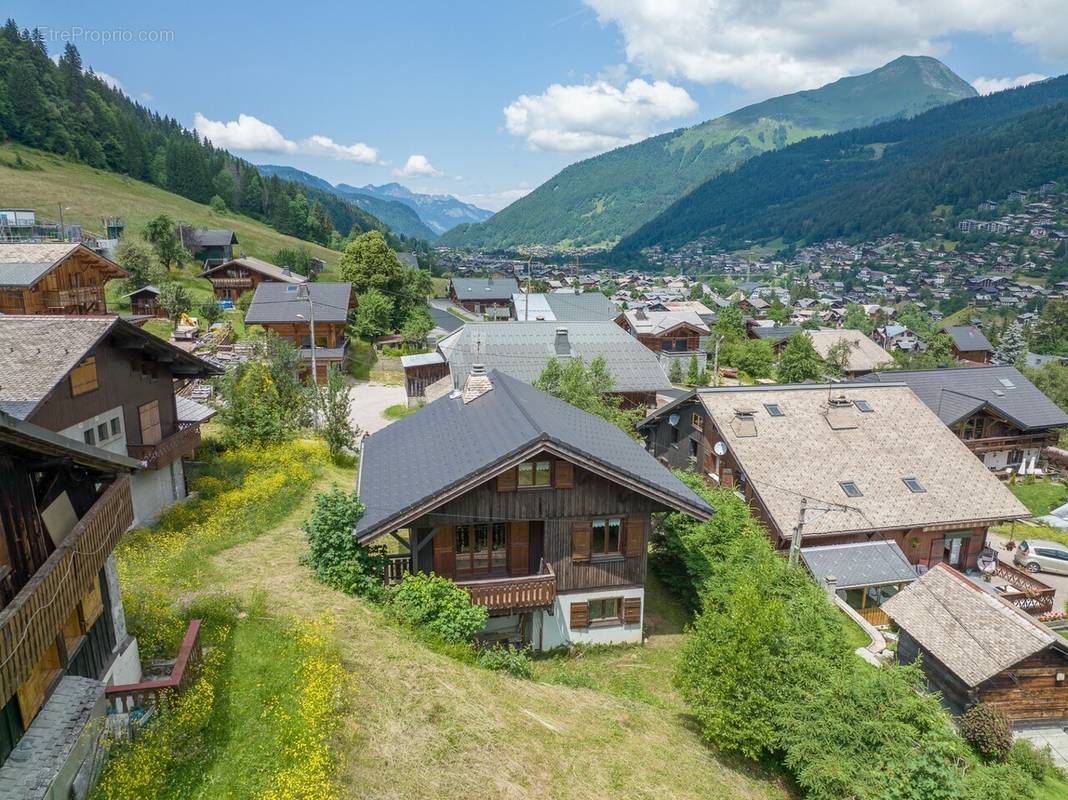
[{"left": 0, "top": 143, "right": 340, "bottom": 268}]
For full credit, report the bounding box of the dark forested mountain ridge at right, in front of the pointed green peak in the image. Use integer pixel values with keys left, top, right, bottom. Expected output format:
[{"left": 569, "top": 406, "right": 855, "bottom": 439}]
[{"left": 613, "top": 75, "right": 1068, "bottom": 256}]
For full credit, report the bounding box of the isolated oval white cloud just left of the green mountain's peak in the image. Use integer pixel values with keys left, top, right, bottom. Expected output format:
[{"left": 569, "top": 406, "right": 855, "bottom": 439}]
[{"left": 504, "top": 78, "right": 697, "bottom": 153}]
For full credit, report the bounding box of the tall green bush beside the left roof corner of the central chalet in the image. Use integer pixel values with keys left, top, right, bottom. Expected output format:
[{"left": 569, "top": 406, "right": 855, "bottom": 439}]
[{"left": 303, "top": 487, "right": 386, "bottom": 597}]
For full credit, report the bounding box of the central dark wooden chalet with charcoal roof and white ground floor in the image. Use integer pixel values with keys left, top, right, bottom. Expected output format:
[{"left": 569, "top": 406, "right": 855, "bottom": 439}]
[{"left": 355, "top": 364, "right": 712, "bottom": 650}]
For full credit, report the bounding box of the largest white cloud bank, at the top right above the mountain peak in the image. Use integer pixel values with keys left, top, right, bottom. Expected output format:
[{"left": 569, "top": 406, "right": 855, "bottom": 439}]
[{"left": 585, "top": 0, "right": 1068, "bottom": 92}]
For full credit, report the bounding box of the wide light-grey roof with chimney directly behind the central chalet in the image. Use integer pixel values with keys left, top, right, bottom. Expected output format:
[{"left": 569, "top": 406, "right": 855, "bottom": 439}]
[{"left": 438, "top": 321, "right": 671, "bottom": 392}]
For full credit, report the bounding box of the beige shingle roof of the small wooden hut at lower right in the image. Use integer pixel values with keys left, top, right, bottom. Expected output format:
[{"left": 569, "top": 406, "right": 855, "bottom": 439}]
[{"left": 882, "top": 564, "right": 1058, "bottom": 687}]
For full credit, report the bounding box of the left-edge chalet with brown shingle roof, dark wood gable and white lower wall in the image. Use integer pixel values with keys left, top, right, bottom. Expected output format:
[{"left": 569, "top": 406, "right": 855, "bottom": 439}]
[{"left": 0, "top": 316, "right": 221, "bottom": 523}]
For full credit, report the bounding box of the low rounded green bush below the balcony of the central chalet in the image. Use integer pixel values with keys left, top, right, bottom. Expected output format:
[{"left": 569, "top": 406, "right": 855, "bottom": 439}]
[{"left": 391, "top": 572, "right": 489, "bottom": 644}]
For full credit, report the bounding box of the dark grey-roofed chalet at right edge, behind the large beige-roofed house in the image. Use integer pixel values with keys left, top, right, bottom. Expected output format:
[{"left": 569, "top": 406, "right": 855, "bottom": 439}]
[{"left": 865, "top": 366, "right": 1068, "bottom": 470}]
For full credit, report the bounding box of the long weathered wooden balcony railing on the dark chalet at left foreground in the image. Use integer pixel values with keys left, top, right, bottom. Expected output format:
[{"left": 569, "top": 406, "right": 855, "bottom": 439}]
[{"left": 0, "top": 474, "right": 134, "bottom": 697}]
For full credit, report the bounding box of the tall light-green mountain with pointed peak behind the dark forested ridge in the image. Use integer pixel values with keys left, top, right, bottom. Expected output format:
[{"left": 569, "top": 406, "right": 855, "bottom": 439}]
[{"left": 441, "top": 56, "right": 976, "bottom": 248}]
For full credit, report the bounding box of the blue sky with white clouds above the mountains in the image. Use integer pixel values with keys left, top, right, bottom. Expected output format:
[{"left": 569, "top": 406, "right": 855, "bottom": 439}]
[{"left": 20, "top": 0, "right": 1068, "bottom": 210}]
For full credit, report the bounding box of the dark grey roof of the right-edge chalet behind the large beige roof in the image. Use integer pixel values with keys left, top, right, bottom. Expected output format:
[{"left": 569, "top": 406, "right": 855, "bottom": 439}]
[{"left": 862, "top": 366, "right": 1068, "bottom": 430}]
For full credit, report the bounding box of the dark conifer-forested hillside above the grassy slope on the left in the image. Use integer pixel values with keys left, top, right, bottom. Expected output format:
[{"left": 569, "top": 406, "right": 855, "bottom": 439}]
[{"left": 0, "top": 19, "right": 418, "bottom": 246}]
